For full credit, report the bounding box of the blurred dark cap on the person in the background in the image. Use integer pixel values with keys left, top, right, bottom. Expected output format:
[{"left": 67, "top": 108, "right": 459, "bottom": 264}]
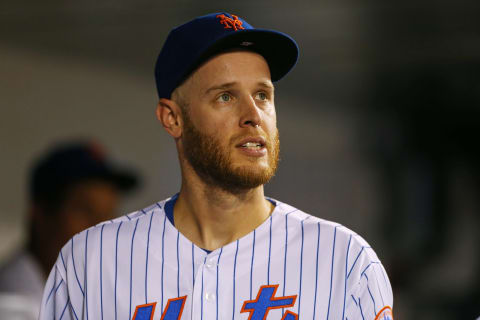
[{"left": 30, "top": 141, "right": 138, "bottom": 200}]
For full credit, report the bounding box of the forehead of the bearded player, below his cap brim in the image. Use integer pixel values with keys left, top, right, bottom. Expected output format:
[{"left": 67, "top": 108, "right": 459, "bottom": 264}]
[{"left": 182, "top": 50, "right": 271, "bottom": 93}]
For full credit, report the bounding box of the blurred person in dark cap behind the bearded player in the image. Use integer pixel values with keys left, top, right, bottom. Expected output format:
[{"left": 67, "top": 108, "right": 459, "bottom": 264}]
[{"left": 0, "top": 141, "right": 136, "bottom": 316}]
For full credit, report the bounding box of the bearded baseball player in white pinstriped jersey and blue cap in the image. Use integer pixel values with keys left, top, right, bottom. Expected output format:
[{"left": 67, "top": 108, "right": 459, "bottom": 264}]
[{"left": 36, "top": 13, "right": 393, "bottom": 320}]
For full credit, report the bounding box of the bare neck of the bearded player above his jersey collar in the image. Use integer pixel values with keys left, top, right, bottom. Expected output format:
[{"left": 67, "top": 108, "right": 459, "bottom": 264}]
[{"left": 174, "top": 171, "right": 274, "bottom": 250}]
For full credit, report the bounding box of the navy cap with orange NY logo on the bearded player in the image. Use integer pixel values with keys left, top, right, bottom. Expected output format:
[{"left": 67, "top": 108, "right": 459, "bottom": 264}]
[{"left": 155, "top": 12, "right": 298, "bottom": 99}]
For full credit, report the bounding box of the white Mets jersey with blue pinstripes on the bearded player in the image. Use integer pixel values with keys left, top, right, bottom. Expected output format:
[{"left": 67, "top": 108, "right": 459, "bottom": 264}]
[{"left": 40, "top": 196, "right": 393, "bottom": 320}]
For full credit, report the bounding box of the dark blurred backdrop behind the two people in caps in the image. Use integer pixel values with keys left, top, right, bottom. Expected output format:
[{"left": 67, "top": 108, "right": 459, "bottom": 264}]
[{"left": 0, "top": 0, "right": 480, "bottom": 319}]
